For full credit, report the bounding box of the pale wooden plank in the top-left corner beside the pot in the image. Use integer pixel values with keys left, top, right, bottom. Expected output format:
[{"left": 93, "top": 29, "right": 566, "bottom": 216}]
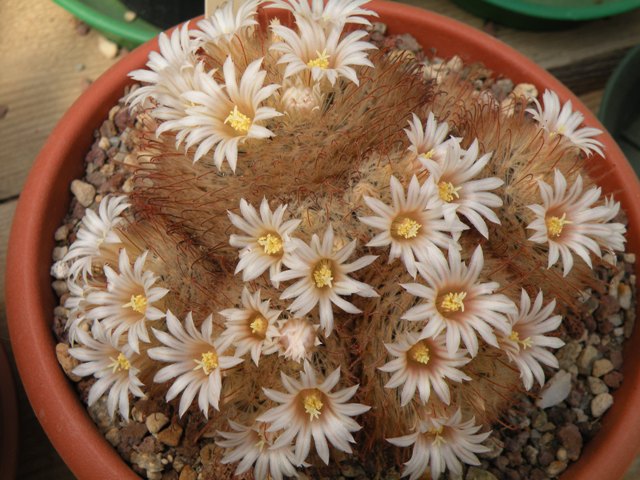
[{"left": 0, "top": 0, "right": 121, "bottom": 200}]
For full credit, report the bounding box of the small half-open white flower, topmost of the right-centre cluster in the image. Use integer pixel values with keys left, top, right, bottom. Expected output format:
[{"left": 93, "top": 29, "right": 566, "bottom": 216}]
[{"left": 404, "top": 112, "right": 460, "bottom": 162}]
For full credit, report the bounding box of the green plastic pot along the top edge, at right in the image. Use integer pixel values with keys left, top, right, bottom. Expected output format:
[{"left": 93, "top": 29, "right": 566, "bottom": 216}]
[{"left": 453, "top": 0, "right": 640, "bottom": 30}]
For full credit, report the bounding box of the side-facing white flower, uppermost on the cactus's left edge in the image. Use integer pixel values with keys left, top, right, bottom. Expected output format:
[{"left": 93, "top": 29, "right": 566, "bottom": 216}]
[{"left": 63, "top": 195, "right": 129, "bottom": 280}]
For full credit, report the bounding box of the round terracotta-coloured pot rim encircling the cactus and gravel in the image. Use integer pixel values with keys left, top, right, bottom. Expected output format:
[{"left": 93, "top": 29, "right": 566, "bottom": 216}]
[{"left": 6, "top": 1, "right": 640, "bottom": 480}]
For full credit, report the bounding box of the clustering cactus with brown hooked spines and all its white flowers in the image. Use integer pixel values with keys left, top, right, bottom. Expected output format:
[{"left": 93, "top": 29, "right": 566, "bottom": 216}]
[{"left": 57, "top": 0, "right": 625, "bottom": 479}]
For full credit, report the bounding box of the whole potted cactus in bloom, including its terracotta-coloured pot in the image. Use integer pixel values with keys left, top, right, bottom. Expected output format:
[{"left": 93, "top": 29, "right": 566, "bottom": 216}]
[{"left": 8, "top": 0, "right": 640, "bottom": 479}]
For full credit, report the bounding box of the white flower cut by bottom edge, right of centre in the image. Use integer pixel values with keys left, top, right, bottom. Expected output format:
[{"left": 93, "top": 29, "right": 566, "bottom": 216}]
[{"left": 387, "top": 409, "right": 491, "bottom": 480}]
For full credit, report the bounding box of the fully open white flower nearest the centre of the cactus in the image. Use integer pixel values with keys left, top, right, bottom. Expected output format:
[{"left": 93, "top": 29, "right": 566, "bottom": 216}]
[{"left": 274, "top": 225, "right": 378, "bottom": 336}]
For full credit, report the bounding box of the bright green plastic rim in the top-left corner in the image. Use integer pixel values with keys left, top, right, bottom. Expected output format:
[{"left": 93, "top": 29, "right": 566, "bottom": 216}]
[{"left": 53, "top": 0, "right": 161, "bottom": 50}]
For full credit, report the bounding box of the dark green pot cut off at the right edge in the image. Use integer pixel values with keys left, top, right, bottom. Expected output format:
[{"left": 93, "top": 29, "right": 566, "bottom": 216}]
[{"left": 598, "top": 45, "right": 640, "bottom": 176}]
